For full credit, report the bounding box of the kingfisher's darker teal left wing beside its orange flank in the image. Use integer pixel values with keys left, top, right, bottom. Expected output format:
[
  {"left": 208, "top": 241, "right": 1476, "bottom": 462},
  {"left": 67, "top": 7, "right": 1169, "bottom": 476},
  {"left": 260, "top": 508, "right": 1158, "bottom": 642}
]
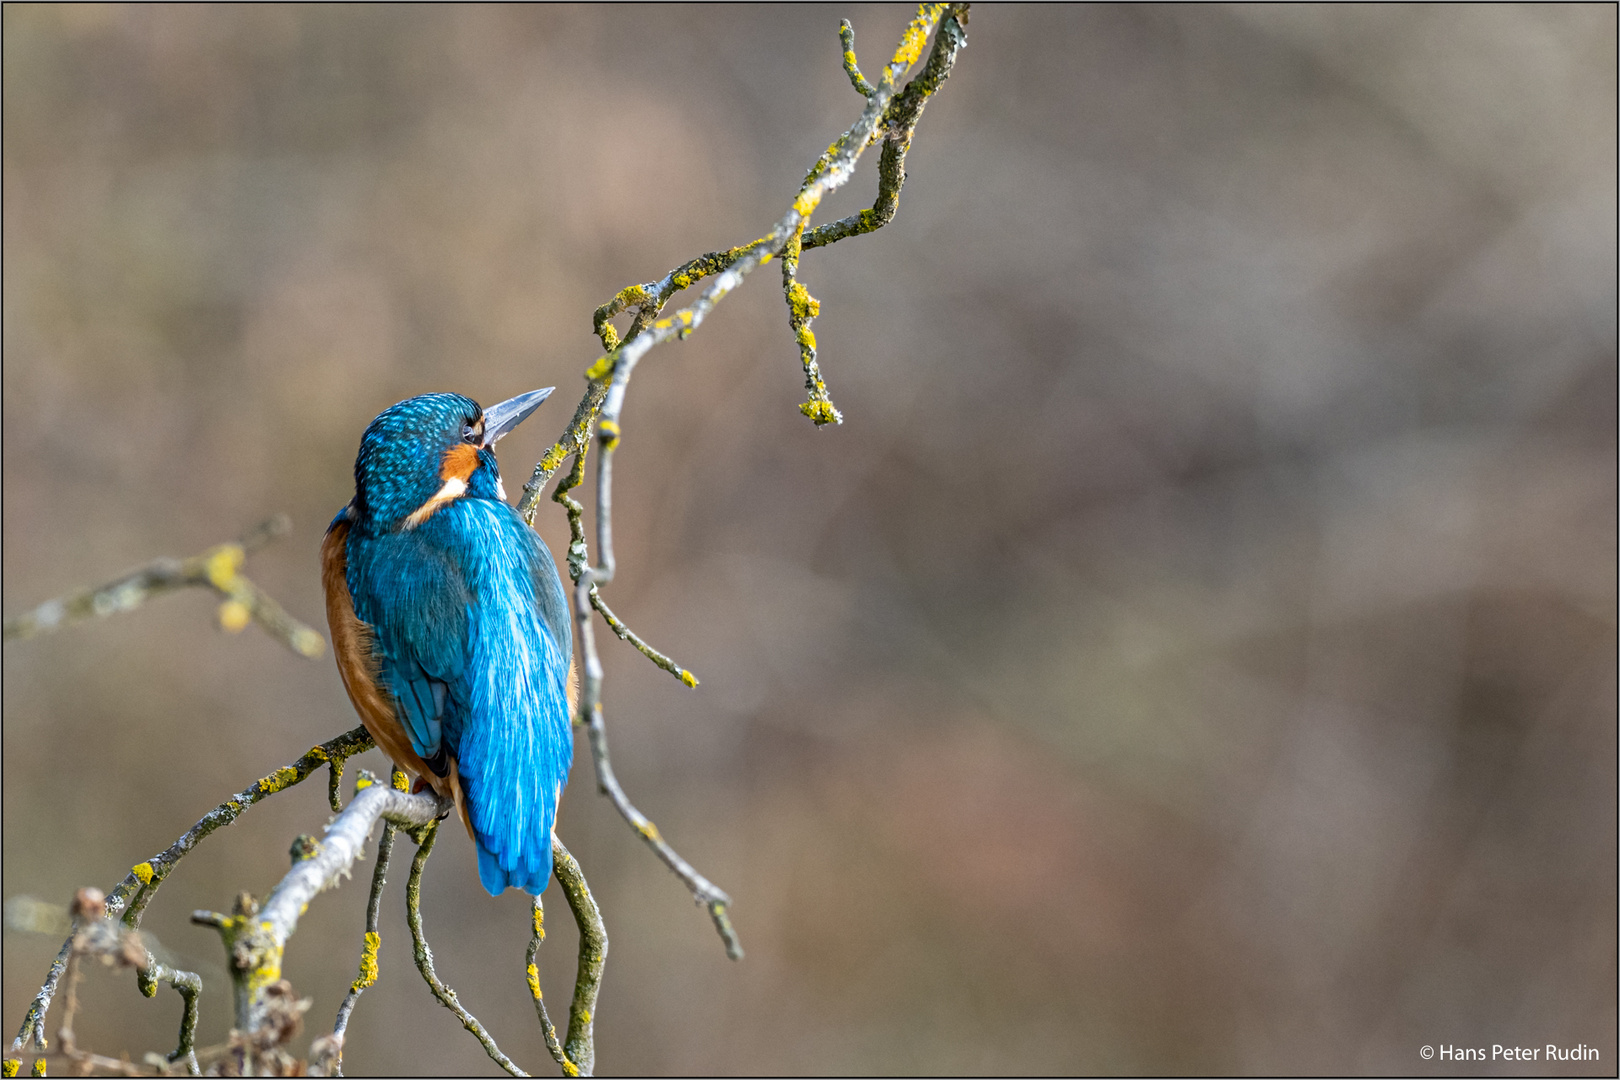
[{"left": 348, "top": 531, "right": 471, "bottom": 764}]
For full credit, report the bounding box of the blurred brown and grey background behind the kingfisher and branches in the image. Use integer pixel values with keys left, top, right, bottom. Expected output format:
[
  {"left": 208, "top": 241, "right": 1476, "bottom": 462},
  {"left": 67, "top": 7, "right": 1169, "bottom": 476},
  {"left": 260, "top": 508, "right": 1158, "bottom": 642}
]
[{"left": 3, "top": 5, "right": 1617, "bottom": 1075}]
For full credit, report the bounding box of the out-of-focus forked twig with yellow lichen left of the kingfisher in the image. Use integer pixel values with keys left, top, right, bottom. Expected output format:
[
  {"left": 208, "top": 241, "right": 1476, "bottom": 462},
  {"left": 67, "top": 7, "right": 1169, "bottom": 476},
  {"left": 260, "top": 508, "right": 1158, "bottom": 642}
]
[{"left": 5, "top": 515, "right": 326, "bottom": 659}]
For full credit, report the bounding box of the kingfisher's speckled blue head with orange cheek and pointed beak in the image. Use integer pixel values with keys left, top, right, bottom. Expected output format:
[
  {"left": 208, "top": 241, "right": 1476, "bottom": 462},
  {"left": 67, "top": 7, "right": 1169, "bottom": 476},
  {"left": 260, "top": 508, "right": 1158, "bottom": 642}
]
[{"left": 353, "top": 387, "right": 556, "bottom": 531}]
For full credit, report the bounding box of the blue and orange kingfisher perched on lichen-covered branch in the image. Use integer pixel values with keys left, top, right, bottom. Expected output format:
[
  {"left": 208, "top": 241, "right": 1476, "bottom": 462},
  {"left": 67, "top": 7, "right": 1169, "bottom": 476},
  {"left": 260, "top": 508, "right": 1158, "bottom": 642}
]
[{"left": 321, "top": 387, "right": 577, "bottom": 895}]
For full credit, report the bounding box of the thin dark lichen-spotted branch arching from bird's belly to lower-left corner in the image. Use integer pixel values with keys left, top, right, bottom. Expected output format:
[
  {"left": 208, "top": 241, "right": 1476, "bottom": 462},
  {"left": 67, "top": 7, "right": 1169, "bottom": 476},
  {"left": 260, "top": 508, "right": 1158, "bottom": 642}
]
[{"left": 6, "top": 727, "right": 376, "bottom": 1056}]
